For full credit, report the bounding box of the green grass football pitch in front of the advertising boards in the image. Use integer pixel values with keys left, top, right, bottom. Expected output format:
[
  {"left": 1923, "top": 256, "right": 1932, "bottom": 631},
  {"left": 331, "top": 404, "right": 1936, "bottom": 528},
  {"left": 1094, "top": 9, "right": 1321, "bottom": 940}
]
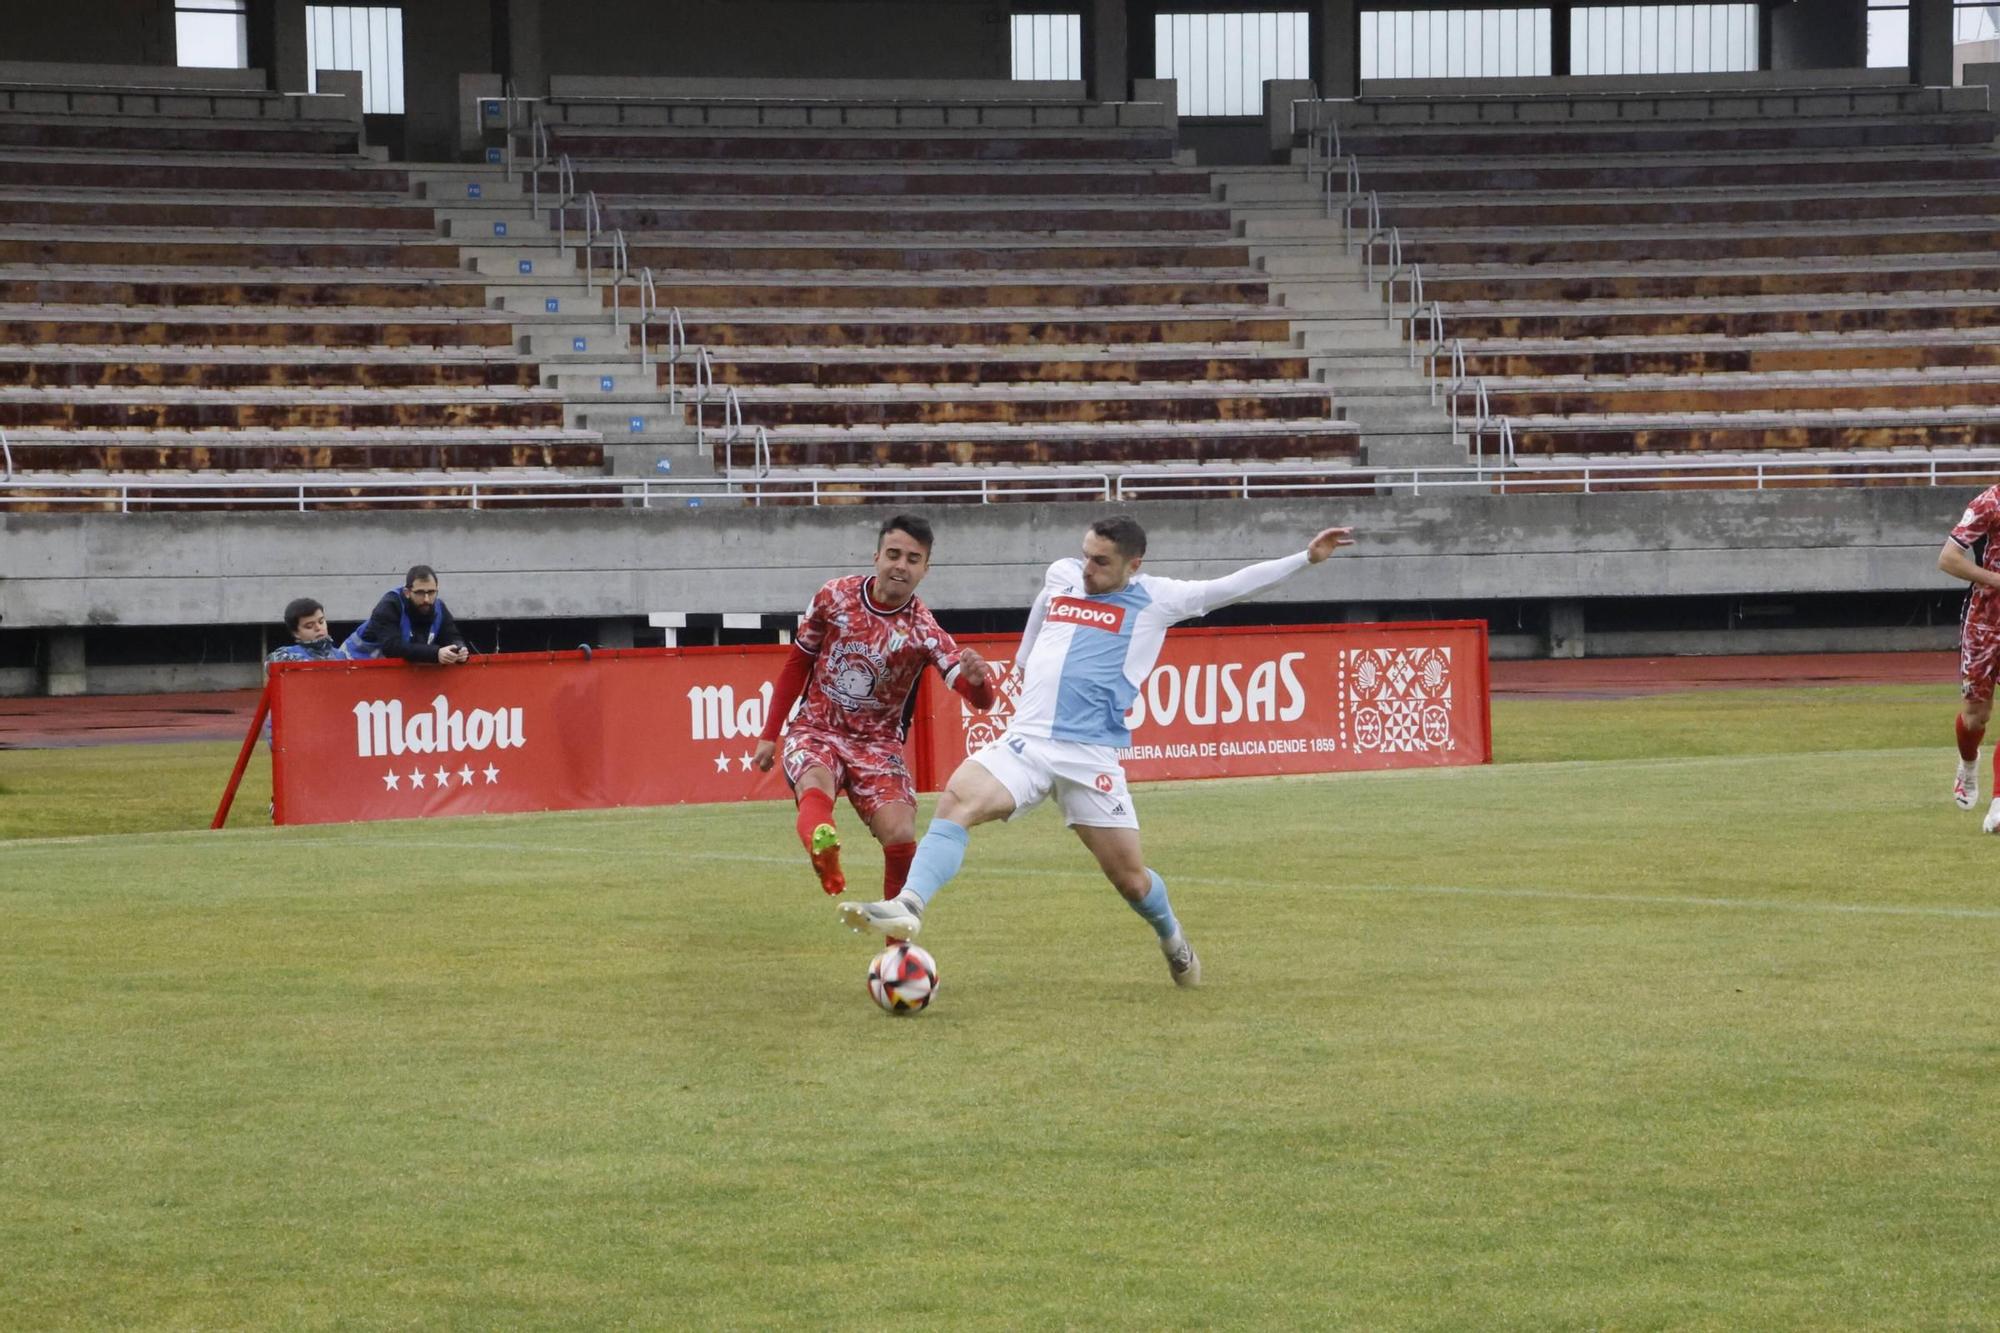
[{"left": 0, "top": 687, "right": 2000, "bottom": 1329}]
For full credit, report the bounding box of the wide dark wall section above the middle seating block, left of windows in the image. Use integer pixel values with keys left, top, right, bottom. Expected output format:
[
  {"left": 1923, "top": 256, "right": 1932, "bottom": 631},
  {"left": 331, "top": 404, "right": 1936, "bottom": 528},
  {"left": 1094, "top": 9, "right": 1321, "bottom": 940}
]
[{"left": 540, "top": 0, "right": 1008, "bottom": 78}]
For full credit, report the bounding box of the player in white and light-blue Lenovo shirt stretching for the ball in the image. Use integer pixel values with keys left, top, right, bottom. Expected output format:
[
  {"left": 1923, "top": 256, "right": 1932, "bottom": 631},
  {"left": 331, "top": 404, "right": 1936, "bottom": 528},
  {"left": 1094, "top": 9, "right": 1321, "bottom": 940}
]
[{"left": 840, "top": 514, "right": 1354, "bottom": 987}]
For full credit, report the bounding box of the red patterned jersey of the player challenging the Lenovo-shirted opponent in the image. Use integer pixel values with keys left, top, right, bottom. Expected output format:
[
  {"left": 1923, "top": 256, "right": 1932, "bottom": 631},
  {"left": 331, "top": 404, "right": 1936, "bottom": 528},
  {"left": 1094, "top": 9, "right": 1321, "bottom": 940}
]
[{"left": 792, "top": 574, "right": 958, "bottom": 743}]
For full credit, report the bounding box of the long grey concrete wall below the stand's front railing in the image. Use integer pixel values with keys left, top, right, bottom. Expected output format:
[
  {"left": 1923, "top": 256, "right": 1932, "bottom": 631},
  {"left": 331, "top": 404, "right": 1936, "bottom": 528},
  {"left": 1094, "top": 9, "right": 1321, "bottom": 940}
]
[{"left": 0, "top": 488, "right": 1976, "bottom": 630}]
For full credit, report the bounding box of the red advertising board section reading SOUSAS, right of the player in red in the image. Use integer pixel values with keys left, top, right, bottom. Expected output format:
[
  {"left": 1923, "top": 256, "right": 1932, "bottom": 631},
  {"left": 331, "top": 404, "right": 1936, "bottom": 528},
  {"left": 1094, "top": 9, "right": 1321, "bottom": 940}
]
[{"left": 916, "top": 620, "right": 1492, "bottom": 791}]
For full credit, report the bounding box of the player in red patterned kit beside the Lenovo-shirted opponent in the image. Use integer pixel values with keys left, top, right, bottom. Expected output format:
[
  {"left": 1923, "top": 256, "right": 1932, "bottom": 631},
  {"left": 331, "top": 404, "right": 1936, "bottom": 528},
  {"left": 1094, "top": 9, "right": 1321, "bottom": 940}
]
[{"left": 752, "top": 514, "right": 998, "bottom": 899}]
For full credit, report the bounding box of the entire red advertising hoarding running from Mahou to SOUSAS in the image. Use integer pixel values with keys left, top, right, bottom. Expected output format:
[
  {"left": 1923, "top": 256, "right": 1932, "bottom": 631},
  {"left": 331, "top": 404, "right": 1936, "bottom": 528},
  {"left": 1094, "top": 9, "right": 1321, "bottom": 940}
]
[{"left": 270, "top": 622, "right": 1492, "bottom": 825}]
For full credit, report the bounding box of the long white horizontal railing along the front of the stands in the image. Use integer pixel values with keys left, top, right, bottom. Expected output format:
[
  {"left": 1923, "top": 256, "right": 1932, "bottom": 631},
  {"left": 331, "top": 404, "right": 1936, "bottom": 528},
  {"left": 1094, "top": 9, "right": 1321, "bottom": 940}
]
[{"left": 11, "top": 448, "right": 2000, "bottom": 512}]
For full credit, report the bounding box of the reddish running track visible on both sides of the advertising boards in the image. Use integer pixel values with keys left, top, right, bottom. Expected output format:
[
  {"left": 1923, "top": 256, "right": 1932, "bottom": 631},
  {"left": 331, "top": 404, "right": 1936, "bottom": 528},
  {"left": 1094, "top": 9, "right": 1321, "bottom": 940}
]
[{"left": 0, "top": 652, "right": 1958, "bottom": 751}]
